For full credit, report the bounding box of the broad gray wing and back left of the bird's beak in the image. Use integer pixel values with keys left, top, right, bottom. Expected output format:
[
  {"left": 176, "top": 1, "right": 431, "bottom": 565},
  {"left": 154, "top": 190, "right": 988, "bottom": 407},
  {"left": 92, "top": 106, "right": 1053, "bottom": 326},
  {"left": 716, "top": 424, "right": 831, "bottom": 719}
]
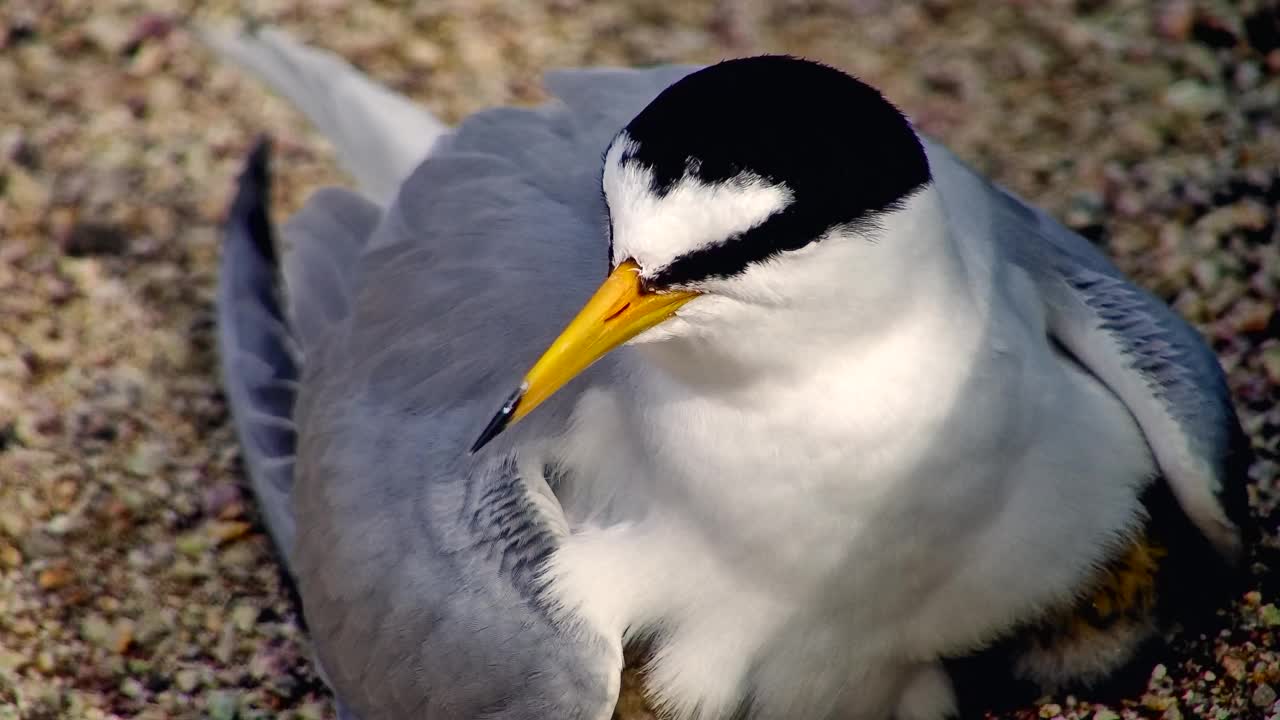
[{"left": 217, "top": 47, "right": 687, "bottom": 720}]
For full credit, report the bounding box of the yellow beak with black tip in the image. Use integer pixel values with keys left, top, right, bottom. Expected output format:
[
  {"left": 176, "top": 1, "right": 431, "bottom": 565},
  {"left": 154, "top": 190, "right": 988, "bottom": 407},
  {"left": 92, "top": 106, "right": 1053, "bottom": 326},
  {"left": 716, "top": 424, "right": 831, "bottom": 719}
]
[{"left": 471, "top": 260, "right": 698, "bottom": 452}]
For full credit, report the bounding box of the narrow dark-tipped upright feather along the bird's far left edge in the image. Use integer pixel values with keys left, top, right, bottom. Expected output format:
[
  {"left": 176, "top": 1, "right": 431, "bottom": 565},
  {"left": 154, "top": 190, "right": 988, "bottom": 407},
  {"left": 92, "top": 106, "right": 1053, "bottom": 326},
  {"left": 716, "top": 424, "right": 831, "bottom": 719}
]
[{"left": 218, "top": 140, "right": 298, "bottom": 559}]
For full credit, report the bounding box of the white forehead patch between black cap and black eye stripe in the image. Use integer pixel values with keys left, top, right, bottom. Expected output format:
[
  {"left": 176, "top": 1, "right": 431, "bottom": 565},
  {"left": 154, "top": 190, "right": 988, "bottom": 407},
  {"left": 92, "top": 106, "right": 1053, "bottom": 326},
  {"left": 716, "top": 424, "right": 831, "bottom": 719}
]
[{"left": 603, "top": 133, "right": 792, "bottom": 275}]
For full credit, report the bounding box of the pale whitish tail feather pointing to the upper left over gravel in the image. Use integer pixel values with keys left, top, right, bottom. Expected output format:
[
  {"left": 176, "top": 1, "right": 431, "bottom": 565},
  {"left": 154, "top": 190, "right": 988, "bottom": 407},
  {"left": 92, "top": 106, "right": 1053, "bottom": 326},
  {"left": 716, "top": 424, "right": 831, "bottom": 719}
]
[{"left": 196, "top": 27, "right": 449, "bottom": 205}]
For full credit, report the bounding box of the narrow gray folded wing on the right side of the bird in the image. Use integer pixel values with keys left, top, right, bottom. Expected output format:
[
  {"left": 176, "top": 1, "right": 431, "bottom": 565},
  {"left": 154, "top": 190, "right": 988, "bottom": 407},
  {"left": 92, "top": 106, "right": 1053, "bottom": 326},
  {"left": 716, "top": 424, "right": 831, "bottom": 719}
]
[{"left": 927, "top": 141, "right": 1251, "bottom": 560}]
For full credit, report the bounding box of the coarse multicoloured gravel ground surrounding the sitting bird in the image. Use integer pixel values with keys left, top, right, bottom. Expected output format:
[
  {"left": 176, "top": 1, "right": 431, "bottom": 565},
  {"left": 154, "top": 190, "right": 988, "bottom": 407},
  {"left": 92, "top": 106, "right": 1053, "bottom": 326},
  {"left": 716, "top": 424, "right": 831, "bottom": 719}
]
[{"left": 0, "top": 0, "right": 1280, "bottom": 720}]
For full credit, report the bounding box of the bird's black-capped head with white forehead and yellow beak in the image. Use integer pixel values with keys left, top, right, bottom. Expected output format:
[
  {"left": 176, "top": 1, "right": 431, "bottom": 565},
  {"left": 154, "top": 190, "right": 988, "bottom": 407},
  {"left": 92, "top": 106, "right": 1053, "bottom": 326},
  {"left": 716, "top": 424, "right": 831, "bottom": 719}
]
[{"left": 472, "top": 55, "right": 932, "bottom": 451}]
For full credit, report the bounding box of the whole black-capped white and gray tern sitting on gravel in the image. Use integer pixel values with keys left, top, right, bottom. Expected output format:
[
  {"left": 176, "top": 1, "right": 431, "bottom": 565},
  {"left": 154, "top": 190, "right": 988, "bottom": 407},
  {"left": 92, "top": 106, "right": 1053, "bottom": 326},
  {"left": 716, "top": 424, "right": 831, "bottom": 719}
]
[{"left": 204, "top": 22, "right": 1248, "bottom": 720}]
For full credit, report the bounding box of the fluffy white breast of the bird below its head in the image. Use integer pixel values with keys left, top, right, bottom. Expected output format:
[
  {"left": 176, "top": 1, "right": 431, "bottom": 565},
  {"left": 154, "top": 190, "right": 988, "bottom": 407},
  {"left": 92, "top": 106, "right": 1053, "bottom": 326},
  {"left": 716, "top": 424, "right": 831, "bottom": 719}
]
[{"left": 535, "top": 235, "right": 1153, "bottom": 717}]
